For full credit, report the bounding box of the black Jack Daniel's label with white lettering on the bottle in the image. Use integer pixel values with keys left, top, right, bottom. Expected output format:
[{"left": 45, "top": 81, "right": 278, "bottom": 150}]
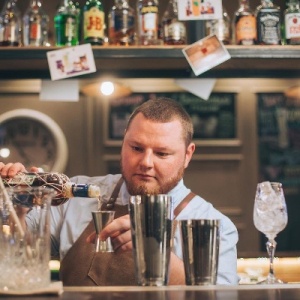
[{"left": 257, "top": 11, "right": 281, "bottom": 45}]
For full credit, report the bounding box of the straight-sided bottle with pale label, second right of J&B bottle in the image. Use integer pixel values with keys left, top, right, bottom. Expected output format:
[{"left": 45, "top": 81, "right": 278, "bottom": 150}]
[{"left": 137, "top": 0, "right": 160, "bottom": 45}]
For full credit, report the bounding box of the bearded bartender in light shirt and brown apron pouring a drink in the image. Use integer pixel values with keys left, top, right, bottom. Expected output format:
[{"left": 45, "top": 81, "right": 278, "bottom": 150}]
[{"left": 0, "top": 98, "right": 238, "bottom": 286}]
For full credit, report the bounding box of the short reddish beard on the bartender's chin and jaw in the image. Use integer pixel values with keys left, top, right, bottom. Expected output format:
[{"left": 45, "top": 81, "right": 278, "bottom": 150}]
[{"left": 121, "top": 160, "right": 185, "bottom": 196}]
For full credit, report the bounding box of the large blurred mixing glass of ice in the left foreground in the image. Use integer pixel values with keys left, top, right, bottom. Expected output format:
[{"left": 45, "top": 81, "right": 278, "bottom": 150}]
[{"left": 0, "top": 186, "right": 54, "bottom": 293}]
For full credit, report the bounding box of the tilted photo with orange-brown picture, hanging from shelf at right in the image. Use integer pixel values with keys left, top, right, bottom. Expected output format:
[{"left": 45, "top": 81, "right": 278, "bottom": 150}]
[{"left": 182, "top": 35, "right": 230, "bottom": 76}]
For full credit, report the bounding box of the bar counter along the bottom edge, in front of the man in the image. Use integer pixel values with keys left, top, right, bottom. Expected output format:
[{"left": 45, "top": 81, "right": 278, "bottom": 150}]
[{"left": 0, "top": 283, "right": 300, "bottom": 300}]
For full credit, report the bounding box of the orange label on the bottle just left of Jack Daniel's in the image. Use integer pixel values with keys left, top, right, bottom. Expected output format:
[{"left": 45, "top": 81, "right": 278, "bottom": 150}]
[{"left": 235, "top": 15, "right": 257, "bottom": 44}]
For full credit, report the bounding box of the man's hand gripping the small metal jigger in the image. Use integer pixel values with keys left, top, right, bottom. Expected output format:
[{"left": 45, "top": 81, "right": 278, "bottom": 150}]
[{"left": 87, "top": 215, "right": 132, "bottom": 252}]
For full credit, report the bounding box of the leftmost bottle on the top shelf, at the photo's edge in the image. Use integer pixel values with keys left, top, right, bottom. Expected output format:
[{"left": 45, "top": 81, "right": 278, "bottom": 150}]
[{"left": 0, "top": 0, "right": 22, "bottom": 46}]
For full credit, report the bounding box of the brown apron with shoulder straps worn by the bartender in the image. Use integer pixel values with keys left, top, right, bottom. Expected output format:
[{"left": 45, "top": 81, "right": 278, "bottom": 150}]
[{"left": 60, "top": 178, "right": 195, "bottom": 286}]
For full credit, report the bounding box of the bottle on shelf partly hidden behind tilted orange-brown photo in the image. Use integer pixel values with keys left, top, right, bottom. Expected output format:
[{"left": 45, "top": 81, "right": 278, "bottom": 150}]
[{"left": 205, "top": 6, "right": 231, "bottom": 45}]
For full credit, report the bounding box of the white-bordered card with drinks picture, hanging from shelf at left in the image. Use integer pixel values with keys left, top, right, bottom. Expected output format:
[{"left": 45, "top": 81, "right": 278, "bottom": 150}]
[{"left": 47, "top": 44, "right": 96, "bottom": 80}]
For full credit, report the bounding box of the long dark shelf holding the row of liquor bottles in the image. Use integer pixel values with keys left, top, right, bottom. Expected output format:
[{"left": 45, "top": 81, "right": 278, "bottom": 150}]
[{"left": 0, "top": 45, "right": 300, "bottom": 79}]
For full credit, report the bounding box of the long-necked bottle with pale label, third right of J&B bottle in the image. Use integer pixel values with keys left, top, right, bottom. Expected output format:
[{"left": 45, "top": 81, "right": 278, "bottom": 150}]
[{"left": 161, "top": 0, "right": 186, "bottom": 45}]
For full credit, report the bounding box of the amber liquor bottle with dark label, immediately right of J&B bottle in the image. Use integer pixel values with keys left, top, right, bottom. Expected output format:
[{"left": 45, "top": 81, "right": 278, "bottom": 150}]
[{"left": 108, "top": 0, "right": 135, "bottom": 46}]
